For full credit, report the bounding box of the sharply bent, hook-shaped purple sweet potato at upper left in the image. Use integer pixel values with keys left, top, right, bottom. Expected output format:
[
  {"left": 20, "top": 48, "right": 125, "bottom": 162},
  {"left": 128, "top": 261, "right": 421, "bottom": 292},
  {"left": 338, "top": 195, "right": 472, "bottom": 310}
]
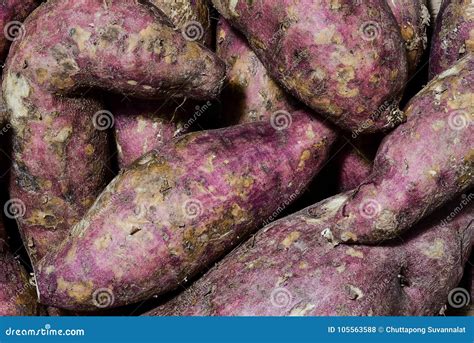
[{"left": 3, "top": 0, "right": 225, "bottom": 263}]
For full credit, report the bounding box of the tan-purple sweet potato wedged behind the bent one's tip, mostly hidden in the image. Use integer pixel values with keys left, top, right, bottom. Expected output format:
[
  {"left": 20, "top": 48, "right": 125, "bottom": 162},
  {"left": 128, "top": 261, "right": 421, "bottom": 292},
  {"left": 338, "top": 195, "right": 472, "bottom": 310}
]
[{"left": 217, "top": 17, "right": 296, "bottom": 125}]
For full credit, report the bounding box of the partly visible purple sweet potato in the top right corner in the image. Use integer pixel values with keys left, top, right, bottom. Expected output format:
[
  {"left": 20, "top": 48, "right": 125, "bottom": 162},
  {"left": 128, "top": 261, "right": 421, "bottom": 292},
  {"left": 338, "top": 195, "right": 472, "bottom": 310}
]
[{"left": 430, "top": 0, "right": 474, "bottom": 78}]
